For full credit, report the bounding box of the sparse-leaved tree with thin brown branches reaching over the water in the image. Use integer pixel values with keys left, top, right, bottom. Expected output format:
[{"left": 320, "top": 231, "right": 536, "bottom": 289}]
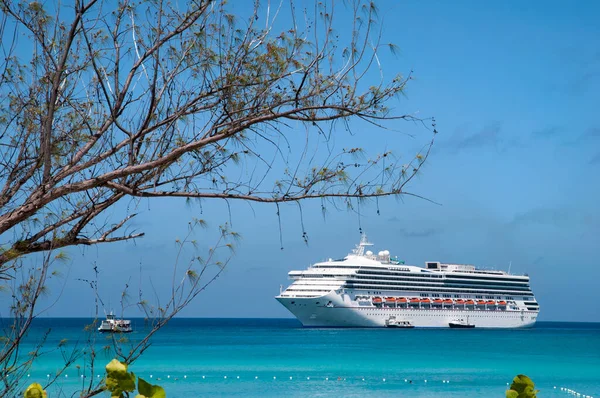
[{"left": 0, "top": 0, "right": 435, "bottom": 391}]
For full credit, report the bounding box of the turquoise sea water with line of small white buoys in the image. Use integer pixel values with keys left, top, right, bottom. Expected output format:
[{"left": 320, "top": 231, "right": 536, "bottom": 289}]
[{"left": 8, "top": 318, "right": 600, "bottom": 398}]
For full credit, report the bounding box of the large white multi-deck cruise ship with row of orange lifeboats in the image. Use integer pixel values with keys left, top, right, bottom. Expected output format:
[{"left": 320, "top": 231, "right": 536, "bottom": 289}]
[{"left": 276, "top": 234, "right": 539, "bottom": 328}]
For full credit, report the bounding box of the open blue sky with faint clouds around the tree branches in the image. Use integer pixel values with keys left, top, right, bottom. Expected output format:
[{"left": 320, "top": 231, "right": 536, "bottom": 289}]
[{"left": 19, "top": 1, "right": 600, "bottom": 322}]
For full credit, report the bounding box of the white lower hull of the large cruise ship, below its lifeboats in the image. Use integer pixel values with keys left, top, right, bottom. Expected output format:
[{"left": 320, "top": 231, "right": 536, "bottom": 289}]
[{"left": 277, "top": 292, "right": 538, "bottom": 328}]
